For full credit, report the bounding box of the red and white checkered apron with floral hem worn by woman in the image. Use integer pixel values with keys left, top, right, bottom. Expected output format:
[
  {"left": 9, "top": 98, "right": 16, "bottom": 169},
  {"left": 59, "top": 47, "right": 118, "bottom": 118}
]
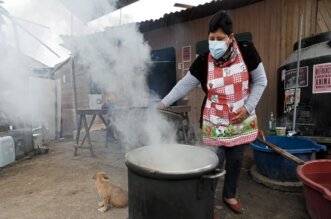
[{"left": 202, "top": 42, "right": 258, "bottom": 147}]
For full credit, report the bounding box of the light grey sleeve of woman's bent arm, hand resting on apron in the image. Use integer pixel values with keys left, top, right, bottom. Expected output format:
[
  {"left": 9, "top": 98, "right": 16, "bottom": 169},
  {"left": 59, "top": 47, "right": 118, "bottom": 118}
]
[{"left": 245, "top": 62, "right": 268, "bottom": 113}]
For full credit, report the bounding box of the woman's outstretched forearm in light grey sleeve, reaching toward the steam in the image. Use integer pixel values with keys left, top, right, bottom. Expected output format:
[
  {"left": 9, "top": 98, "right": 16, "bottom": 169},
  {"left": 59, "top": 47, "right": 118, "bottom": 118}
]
[{"left": 161, "top": 71, "right": 200, "bottom": 107}]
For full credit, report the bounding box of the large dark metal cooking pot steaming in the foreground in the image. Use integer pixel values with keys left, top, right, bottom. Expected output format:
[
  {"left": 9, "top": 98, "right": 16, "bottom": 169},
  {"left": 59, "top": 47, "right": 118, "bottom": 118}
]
[{"left": 125, "top": 144, "right": 225, "bottom": 219}]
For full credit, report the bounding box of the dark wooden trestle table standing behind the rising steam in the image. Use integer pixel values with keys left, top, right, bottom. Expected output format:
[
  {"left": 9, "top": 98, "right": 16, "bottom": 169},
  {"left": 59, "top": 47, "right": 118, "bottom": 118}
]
[{"left": 74, "top": 106, "right": 191, "bottom": 156}]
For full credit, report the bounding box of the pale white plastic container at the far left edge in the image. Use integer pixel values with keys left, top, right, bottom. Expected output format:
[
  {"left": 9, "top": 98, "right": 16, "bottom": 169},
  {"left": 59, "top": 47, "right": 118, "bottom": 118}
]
[{"left": 0, "top": 136, "right": 15, "bottom": 167}]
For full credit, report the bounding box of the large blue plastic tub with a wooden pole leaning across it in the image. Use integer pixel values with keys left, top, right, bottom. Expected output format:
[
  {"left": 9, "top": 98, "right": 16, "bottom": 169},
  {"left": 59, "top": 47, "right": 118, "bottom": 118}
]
[{"left": 251, "top": 136, "right": 326, "bottom": 181}]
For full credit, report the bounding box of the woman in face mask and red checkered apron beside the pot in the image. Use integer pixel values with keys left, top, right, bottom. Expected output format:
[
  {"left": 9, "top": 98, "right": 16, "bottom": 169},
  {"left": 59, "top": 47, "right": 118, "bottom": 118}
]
[{"left": 158, "top": 11, "right": 267, "bottom": 213}]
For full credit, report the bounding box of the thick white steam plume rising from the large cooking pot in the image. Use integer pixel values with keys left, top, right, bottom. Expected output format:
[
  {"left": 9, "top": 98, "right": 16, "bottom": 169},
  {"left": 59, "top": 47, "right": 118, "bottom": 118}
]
[{"left": 64, "top": 21, "right": 179, "bottom": 149}]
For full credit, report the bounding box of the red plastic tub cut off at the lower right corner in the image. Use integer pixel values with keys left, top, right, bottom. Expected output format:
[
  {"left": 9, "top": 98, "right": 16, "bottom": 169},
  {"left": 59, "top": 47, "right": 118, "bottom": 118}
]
[{"left": 297, "top": 160, "right": 331, "bottom": 219}]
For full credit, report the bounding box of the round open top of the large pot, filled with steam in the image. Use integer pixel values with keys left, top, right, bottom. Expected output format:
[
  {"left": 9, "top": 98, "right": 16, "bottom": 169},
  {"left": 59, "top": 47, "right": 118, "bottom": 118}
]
[{"left": 125, "top": 144, "right": 218, "bottom": 175}]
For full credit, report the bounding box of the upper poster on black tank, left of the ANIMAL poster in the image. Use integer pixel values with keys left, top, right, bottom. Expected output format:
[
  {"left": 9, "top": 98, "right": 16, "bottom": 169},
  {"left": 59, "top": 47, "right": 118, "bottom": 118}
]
[{"left": 284, "top": 66, "right": 308, "bottom": 90}]
